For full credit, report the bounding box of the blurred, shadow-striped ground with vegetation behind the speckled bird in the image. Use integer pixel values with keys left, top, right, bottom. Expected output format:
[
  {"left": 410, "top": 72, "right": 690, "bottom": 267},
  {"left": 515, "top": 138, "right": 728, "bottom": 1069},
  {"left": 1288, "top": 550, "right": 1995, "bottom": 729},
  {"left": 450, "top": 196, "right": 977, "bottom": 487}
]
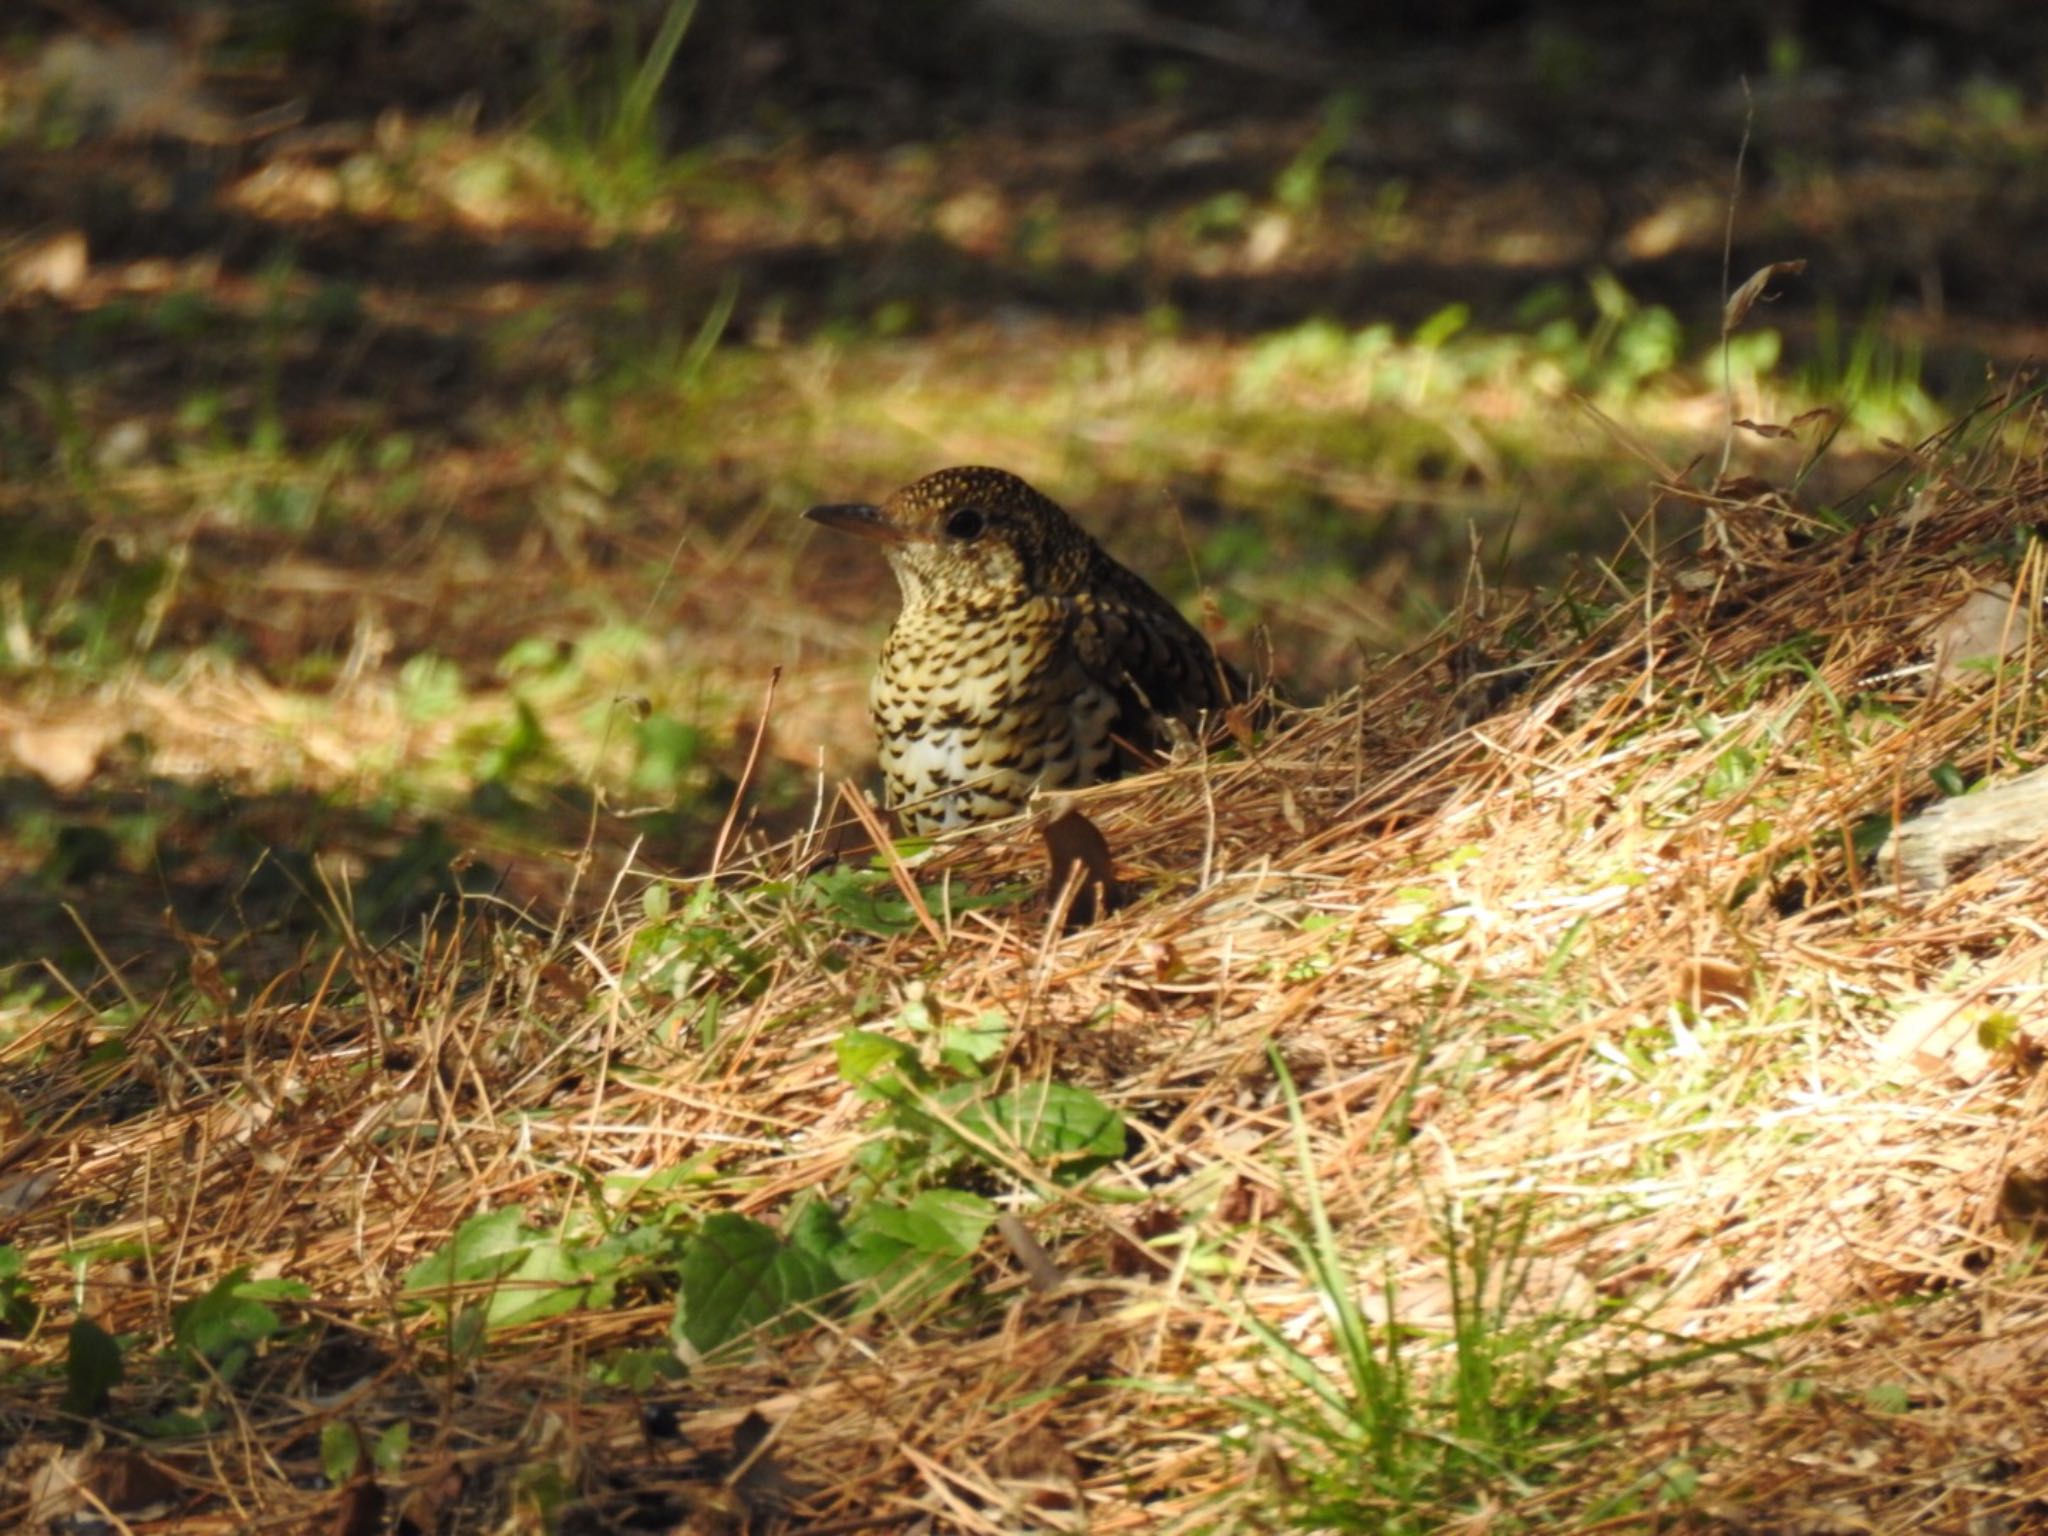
[{"left": 0, "top": 0, "right": 2048, "bottom": 1003}]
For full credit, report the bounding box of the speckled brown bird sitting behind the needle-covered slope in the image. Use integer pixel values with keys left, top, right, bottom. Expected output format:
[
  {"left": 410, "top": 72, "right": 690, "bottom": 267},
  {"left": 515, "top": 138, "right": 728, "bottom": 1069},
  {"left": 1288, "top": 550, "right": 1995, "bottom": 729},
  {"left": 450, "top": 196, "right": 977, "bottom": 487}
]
[{"left": 805, "top": 465, "right": 1245, "bottom": 836}]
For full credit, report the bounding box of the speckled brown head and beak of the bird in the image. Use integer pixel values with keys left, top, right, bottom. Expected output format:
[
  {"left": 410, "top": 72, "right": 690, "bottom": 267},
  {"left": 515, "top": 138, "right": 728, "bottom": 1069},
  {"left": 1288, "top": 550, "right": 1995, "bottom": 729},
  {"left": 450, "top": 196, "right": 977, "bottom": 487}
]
[{"left": 805, "top": 467, "right": 1094, "bottom": 608}]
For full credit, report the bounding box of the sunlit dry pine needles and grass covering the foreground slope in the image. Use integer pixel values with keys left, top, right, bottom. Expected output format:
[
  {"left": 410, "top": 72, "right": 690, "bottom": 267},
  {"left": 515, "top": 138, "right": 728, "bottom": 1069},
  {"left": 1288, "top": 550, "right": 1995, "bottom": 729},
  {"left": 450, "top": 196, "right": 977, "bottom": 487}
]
[{"left": 12, "top": 415, "right": 2048, "bottom": 1532}]
